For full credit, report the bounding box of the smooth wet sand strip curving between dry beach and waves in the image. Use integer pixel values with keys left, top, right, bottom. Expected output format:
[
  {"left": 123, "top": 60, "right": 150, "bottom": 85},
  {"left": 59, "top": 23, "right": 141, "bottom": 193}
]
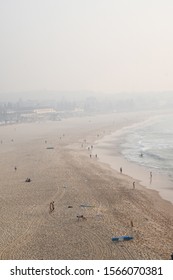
[{"left": 95, "top": 113, "right": 173, "bottom": 204}]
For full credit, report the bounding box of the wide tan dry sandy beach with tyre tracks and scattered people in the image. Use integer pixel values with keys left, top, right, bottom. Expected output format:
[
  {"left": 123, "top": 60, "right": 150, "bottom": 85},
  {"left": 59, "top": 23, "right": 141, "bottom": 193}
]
[{"left": 0, "top": 110, "right": 173, "bottom": 260}]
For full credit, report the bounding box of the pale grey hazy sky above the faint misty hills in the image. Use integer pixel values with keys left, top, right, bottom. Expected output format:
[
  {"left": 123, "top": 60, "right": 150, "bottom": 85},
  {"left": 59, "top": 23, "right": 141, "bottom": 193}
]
[{"left": 0, "top": 0, "right": 173, "bottom": 92}]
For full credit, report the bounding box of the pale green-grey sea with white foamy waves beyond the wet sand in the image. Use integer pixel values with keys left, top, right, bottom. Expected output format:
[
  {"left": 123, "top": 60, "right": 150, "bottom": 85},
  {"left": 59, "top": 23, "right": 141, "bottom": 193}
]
[{"left": 120, "top": 114, "right": 173, "bottom": 181}]
